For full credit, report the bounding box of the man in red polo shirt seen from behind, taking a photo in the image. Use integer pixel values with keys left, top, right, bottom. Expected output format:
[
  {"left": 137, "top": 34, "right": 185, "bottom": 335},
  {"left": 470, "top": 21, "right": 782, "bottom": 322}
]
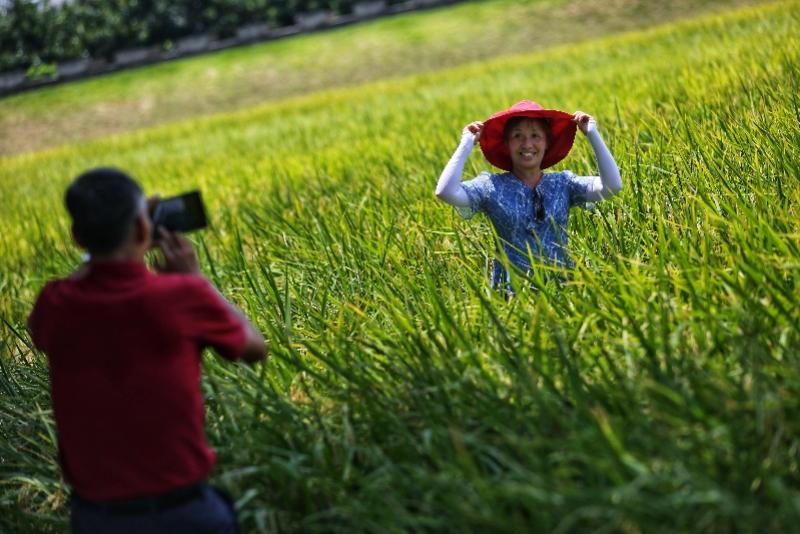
[{"left": 28, "top": 168, "right": 266, "bottom": 533}]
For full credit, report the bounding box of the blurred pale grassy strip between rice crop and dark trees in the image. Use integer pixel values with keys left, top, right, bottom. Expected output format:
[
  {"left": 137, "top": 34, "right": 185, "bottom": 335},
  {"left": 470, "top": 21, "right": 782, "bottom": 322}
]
[{"left": 0, "top": 0, "right": 764, "bottom": 156}]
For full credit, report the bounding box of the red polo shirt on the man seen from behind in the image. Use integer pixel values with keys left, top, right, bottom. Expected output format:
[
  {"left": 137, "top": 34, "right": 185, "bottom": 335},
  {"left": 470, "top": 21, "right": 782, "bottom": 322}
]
[{"left": 29, "top": 263, "right": 245, "bottom": 500}]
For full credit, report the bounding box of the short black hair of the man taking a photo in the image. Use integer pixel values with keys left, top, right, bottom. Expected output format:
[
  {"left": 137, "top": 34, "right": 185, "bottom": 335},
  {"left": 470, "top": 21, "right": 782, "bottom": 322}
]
[{"left": 64, "top": 168, "right": 143, "bottom": 254}]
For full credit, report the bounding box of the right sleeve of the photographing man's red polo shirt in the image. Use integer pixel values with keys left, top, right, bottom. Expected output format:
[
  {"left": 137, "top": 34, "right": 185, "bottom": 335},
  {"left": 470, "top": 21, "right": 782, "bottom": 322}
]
[{"left": 184, "top": 276, "right": 246, "bottom": 360}]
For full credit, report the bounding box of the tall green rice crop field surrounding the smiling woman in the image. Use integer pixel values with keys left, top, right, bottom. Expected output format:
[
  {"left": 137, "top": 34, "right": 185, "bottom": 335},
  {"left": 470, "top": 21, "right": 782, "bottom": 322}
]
[{"left": 0, "top": 1, "right": 800, "bottom": 532}]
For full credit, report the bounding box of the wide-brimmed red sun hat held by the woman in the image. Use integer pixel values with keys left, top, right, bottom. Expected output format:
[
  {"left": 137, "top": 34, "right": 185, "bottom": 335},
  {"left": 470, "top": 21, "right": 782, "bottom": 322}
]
[{"left": 480, "top": 100, "right": 578, "bottom": 171}]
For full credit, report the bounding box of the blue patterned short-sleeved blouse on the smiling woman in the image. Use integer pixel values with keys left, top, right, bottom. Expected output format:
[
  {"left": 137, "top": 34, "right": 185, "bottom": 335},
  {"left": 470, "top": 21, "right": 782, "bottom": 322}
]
[{"left": 456, "top": 171, "right": 592, "bottom": 288}]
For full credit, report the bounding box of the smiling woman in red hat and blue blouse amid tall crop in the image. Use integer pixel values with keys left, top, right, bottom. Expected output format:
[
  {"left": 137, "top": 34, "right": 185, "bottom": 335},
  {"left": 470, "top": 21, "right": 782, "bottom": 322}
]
[{"left": 436, "top": 100, "right": 622, "bottom": 294}]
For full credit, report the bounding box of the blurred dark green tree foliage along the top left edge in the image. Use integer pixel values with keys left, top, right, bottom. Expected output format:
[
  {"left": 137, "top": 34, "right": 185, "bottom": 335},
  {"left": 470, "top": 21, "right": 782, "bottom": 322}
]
[{"left": 0, "top": 0, "right": 376, "bottom": 72}]
